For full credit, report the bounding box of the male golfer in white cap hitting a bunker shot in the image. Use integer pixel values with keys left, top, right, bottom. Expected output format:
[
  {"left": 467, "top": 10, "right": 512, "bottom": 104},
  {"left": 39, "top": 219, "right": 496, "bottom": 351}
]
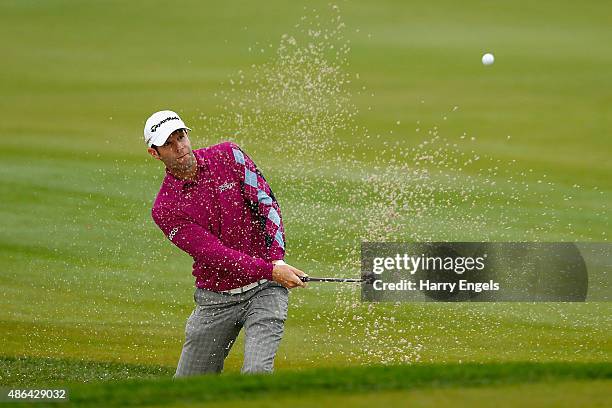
[{"left": 144, "top": 110, "right": 305, "bottom": 377}]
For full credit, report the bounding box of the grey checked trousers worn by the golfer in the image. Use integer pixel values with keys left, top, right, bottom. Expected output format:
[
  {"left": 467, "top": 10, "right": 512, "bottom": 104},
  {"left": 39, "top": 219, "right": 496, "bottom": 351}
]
[{"left": 174, "top": 282, "right": 289, "bottom": 377}]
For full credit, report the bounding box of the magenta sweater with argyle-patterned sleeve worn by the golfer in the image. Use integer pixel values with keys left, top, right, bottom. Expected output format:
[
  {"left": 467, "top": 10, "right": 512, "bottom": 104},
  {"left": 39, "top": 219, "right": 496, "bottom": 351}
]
[{"left": 151, "top": 142, "right": 285, "bottom": 291}]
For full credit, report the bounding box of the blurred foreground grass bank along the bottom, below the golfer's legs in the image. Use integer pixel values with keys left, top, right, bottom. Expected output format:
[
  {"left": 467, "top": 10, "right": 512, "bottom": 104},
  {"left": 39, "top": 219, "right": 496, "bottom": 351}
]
[{"left": 5, "top": 363, "right": 612, "bottom": 407}]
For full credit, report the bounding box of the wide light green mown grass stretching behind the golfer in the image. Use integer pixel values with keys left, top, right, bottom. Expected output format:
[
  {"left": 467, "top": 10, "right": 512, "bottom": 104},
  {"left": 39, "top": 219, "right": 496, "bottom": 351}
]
[{"left": 0, "top": 0, "right": 612, "bottom": 406}]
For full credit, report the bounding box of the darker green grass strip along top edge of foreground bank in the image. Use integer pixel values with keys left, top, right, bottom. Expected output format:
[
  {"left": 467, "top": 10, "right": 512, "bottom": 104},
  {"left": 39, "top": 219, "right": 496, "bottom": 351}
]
[{"left": 2, "top": 363, "right": 612, "bottom": 406}]
